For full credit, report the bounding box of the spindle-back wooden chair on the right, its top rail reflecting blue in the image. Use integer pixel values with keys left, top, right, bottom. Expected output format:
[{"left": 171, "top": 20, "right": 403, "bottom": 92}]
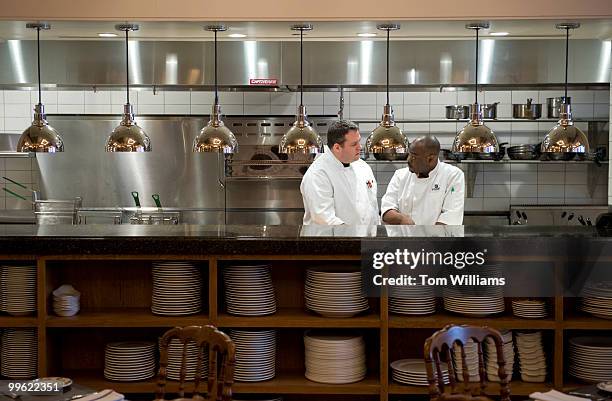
[{"left": 424, "top": 325, "right": 510, "bottom": 401}]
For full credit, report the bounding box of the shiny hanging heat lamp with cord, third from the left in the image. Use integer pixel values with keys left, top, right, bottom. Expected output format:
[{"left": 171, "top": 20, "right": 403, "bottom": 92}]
[{"left": 193, "top": 25, "right": 238, "bottom": 154}]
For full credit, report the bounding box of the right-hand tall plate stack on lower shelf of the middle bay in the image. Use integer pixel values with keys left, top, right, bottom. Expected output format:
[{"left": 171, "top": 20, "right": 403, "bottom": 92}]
[{"left": 304, "top": 331, "right": 366, "bottom": 384}]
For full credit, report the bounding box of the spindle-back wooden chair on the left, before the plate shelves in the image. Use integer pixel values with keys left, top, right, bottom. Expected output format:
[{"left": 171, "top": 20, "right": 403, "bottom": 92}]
[{"left": 155, "top": 326, "right": 236, "bottom": 401}]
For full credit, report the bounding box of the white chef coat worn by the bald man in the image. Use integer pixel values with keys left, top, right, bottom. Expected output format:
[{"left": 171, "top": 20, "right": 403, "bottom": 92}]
[{"left": 380, "top": 161, "right": 465, "bottom": 225}]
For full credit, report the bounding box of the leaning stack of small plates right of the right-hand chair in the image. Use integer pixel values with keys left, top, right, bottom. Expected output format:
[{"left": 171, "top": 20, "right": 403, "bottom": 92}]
[{"left": 515, "top": 331, "right": 546, "bottom": 383}]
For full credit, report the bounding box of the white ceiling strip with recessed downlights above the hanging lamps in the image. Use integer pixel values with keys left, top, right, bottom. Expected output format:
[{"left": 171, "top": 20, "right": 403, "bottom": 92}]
[{"left": 0, "top": 19, "right": 612, "bottom": 40}]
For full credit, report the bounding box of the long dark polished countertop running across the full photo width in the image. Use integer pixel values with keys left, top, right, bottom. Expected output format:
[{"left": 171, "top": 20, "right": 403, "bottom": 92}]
[{"left": 0, "top": 224, "right": 612, "bottom": 255}]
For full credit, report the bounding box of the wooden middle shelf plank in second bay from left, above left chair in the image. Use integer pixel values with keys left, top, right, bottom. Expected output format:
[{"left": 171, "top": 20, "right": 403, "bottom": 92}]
[{"left": 46, "top": 308, "right": 209, "bottom": 327}]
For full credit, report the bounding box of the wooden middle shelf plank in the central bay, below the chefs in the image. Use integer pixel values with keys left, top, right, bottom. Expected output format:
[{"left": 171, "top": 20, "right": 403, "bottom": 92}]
[{"left": 218, "top": 308, "right": 380, "bottom": 328}]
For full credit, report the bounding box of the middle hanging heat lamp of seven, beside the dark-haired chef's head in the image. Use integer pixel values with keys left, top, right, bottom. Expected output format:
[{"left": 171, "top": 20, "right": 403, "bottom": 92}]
[{"left": 278, "top": 24, "right": 323, "bottom": 154}]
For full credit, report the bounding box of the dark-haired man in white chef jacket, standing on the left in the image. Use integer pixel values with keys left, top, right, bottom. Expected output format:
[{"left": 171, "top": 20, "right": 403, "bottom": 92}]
[{"left": 300, "top": 120, "right": 380, "bottom": 225}]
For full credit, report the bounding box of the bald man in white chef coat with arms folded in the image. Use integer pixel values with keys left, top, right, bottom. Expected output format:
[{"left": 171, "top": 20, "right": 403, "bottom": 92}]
[{"left": 381, "top": 136, "right": 465, "bottom": 225}]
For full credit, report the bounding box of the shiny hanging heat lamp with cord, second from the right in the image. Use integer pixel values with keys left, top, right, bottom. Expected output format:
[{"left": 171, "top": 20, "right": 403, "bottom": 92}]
[{"left": 452, "top": 22, "right": 499, "bottom": 153}]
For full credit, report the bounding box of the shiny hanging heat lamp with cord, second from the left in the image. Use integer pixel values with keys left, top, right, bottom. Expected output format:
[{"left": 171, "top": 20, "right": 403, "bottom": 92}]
[{"left": 105, "top": 24, "right": 151, "bottom": 152}]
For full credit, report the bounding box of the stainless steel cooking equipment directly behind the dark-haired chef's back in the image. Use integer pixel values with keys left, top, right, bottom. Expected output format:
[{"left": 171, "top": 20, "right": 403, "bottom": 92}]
[{"left": 225, "top": 116, "right": 336, "bottom": 224}]
